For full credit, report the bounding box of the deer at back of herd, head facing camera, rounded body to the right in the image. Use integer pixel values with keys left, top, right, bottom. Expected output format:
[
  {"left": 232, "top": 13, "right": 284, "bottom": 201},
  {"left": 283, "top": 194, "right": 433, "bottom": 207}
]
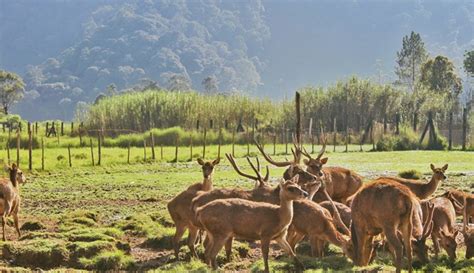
[{"left": 301, "top": 141, "right": 362, "bottom": 204}]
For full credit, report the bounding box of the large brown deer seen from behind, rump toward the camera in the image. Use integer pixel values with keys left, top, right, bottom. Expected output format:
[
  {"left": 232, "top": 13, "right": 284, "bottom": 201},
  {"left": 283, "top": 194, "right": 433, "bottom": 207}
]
[{"left": 348, "top": 179, "right": 432, "bottom": 272}]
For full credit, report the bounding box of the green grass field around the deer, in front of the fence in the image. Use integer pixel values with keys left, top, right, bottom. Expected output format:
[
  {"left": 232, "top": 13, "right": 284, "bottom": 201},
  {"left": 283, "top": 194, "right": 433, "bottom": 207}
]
[{"left": 0, "top": 145, "right": 474, "bottom": 272}]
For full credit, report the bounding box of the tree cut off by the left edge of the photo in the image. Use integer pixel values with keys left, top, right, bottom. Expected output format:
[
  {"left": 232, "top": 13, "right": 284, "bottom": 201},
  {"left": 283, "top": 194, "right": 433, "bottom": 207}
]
[{"left": 0, "top": 70, "right": 25, "bottom": 115}]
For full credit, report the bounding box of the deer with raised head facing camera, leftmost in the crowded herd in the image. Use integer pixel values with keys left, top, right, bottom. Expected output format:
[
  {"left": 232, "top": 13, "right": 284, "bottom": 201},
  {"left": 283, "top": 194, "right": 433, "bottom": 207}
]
[{"left": 168, "top": 158, "right": 220, "bottom": 259}]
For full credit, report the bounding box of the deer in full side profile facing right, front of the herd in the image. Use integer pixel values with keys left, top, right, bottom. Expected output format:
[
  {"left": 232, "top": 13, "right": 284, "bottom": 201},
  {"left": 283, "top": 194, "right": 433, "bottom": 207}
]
[{"left": 196, "top": 175, "right": 308, "bottom": 272}]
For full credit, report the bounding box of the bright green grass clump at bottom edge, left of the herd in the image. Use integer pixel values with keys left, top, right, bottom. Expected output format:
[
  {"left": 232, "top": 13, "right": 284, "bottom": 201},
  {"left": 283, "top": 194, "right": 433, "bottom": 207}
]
[{"left": 79, "top": 250, "right": 134, "bottom": 270}]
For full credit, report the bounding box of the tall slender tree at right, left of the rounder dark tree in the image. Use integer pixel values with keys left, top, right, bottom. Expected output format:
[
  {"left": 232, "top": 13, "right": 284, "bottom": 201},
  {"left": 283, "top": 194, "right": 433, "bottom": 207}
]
[{"left": 395, "top": 31, "right": 428, "bottom": 92}]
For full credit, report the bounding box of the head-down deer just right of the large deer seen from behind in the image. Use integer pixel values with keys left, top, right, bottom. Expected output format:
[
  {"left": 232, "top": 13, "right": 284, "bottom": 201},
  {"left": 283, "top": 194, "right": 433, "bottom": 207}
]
[{"left": 422, "top": 197, "right": 459, "bottom": 261}]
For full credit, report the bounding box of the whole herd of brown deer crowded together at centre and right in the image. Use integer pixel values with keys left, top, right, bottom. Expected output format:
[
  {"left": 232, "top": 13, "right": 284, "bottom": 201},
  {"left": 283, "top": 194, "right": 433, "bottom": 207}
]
[{"left": 168, "top": 139, "right": 474, "bottom": 272}]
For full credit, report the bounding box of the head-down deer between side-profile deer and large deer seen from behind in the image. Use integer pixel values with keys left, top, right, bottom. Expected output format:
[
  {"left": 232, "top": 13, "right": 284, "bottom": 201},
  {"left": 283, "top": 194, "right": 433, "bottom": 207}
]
[{"left": 288, "top": 200, "right": 349, "bottom": 257}]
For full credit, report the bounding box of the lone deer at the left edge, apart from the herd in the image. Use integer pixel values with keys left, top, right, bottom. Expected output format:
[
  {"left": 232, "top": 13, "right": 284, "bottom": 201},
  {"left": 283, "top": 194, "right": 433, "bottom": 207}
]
[{"left": 0, "top": 164, "right": 26, "bottom": 241}]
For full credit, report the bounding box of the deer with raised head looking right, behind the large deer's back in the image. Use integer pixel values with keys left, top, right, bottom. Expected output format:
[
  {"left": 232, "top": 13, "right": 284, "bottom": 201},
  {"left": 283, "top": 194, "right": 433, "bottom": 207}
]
[{"left": 379, "top": 164, "right": 448, "bottom": 199}]
